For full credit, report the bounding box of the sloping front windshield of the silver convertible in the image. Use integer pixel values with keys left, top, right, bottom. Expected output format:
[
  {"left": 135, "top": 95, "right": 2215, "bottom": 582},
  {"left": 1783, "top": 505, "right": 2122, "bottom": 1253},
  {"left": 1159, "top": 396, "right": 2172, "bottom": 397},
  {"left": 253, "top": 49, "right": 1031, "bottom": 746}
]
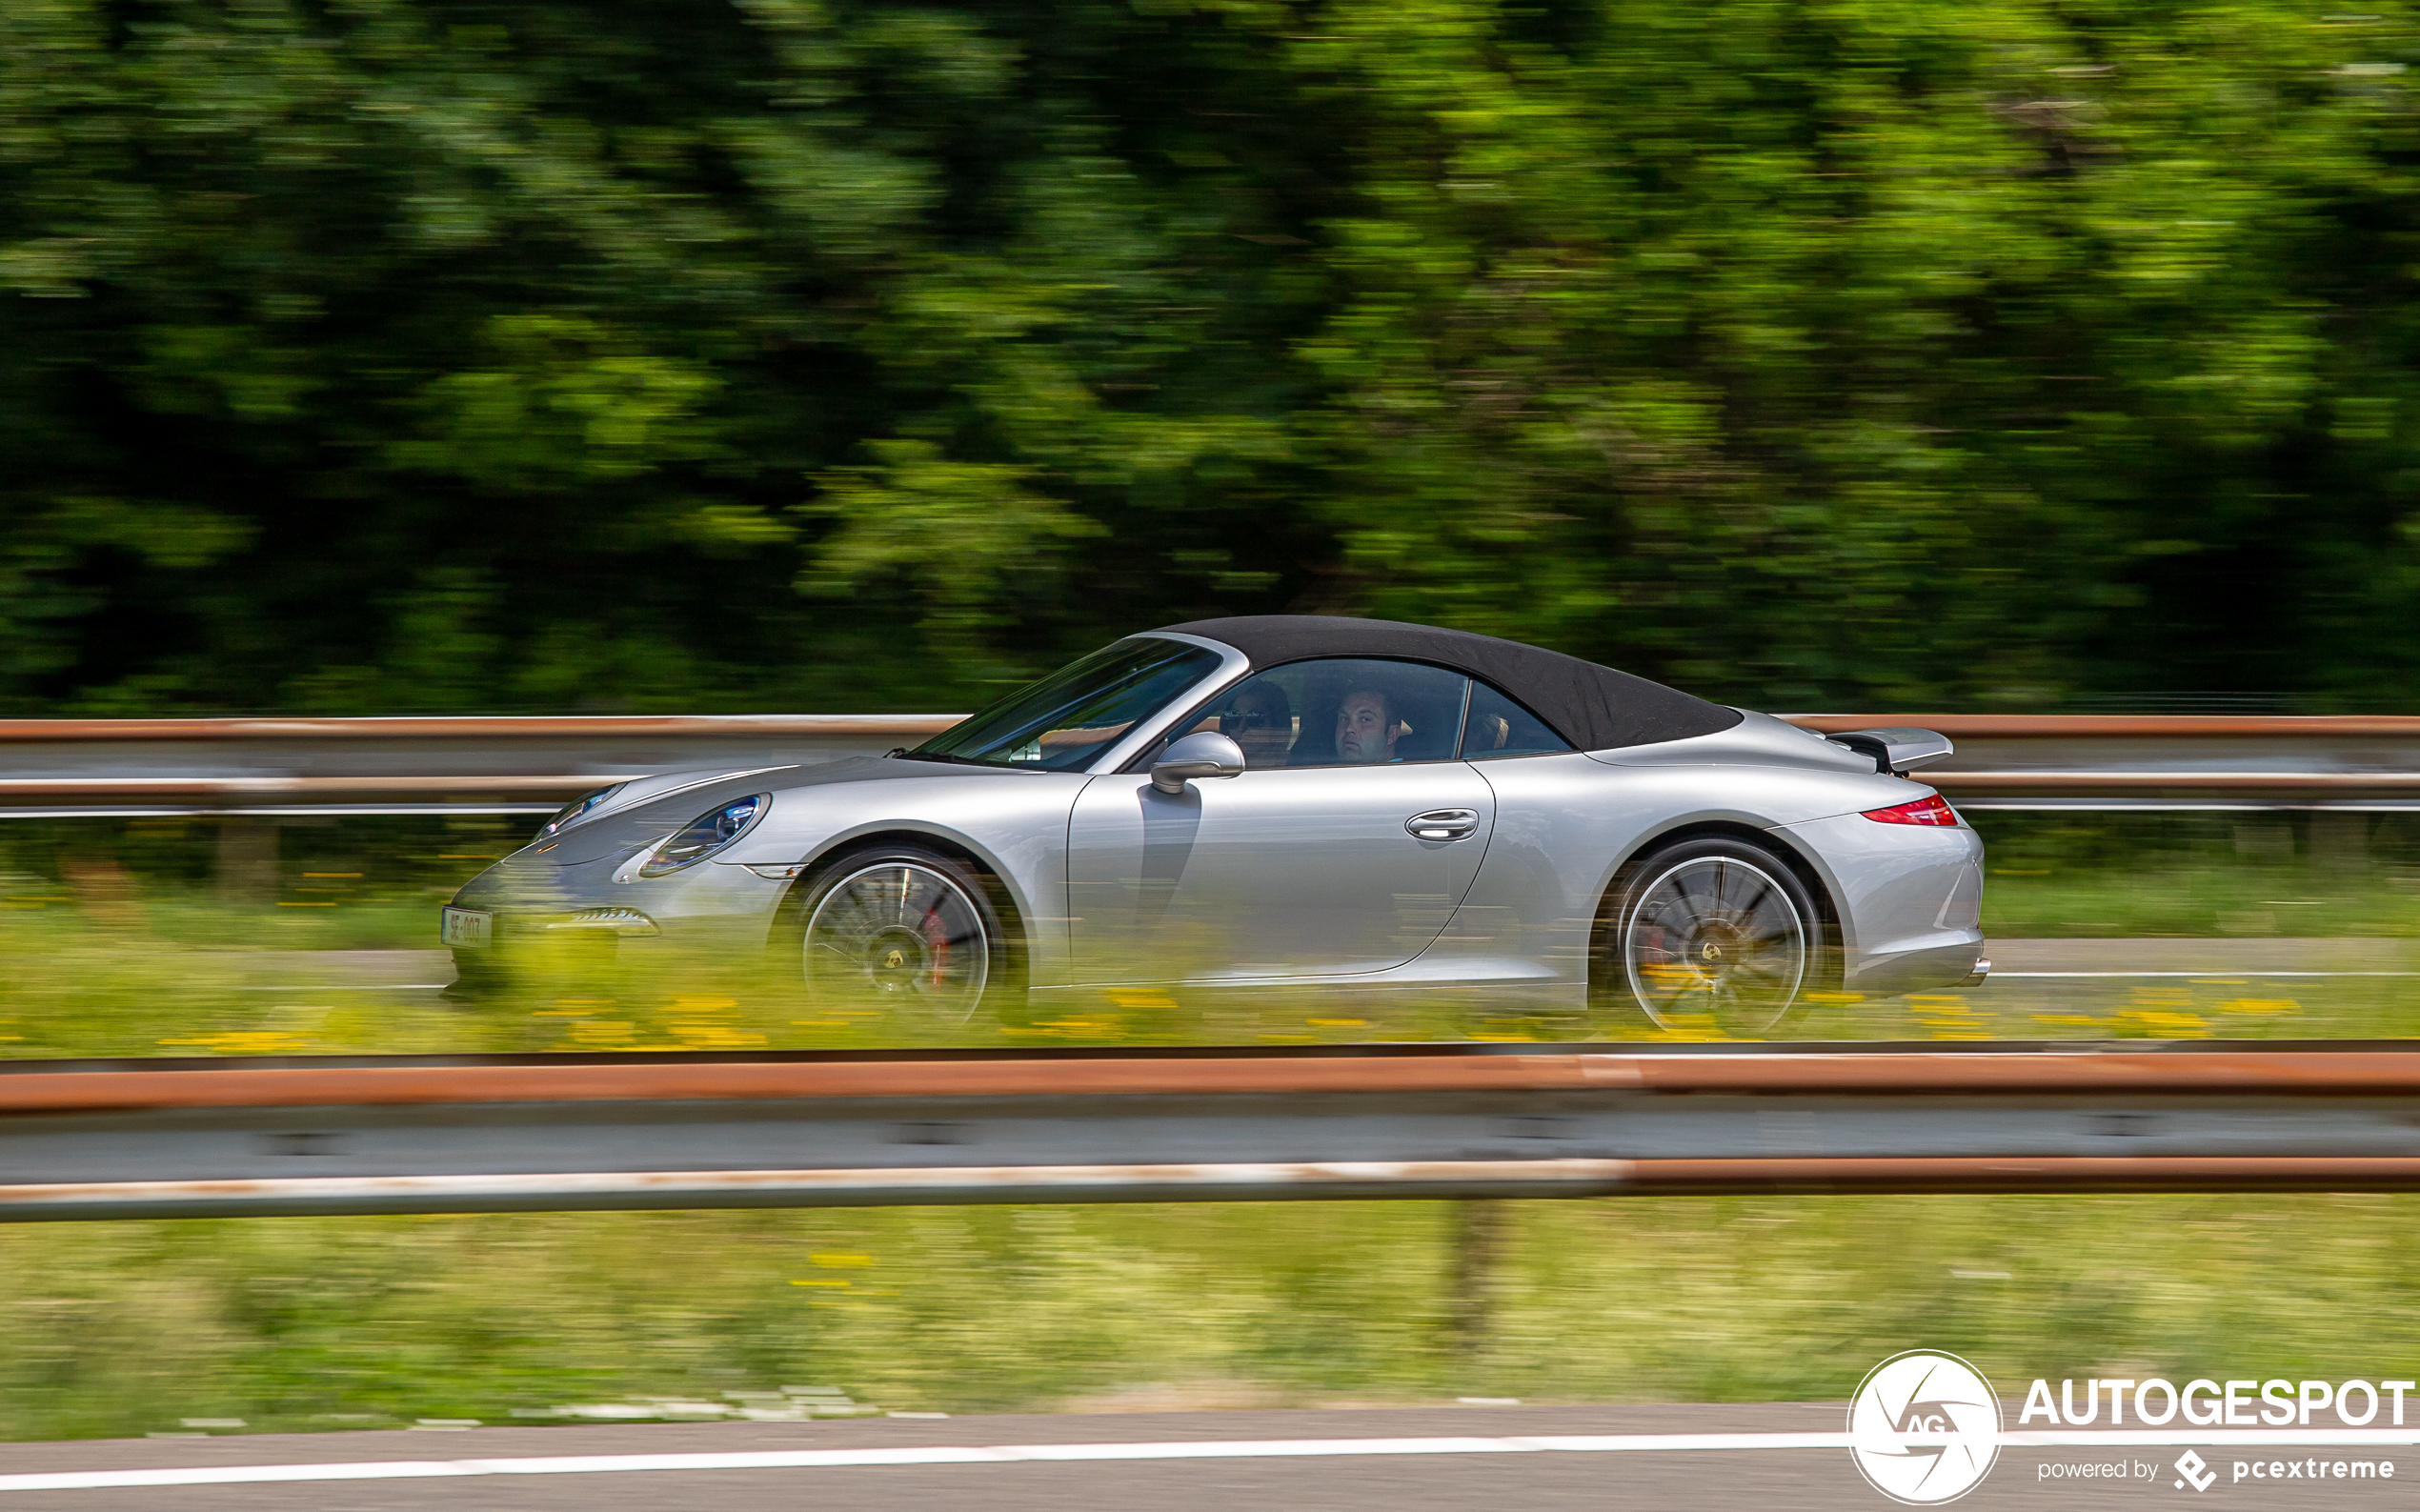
[{"left": 908, "top": 641, "right": 1220, "bottom": 772}]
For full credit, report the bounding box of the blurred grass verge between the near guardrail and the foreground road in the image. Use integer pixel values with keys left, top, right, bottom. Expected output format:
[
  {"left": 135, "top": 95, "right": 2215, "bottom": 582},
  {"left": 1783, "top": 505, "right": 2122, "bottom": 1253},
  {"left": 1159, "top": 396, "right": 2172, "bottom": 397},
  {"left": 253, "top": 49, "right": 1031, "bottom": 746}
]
[{"left": 0, "top": 1195, "right": 2420, "bottom": 1440}]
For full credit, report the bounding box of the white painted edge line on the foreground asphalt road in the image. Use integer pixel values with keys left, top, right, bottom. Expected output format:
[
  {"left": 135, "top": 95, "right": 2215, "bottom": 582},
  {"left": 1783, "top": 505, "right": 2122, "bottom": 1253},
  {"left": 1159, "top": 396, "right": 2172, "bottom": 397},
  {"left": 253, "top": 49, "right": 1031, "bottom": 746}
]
[{"left": 13, "top": 1427, "right": 2420, "bottom": 1493}]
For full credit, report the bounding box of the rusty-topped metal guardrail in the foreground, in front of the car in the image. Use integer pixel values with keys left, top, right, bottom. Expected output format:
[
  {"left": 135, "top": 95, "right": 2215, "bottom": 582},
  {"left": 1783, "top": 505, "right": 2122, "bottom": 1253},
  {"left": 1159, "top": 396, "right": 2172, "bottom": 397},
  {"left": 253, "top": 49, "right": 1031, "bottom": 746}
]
[{"left": 13, "top": 1040, "right": 2420, "bottom": 1221}]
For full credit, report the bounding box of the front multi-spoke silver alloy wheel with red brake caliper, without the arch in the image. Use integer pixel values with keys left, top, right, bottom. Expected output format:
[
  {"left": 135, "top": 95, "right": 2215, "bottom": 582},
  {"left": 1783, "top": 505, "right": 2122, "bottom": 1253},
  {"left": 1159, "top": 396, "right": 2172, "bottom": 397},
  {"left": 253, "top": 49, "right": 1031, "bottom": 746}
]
[{"left": 801, "top": 861, "right": 992, "bottom": 1023}]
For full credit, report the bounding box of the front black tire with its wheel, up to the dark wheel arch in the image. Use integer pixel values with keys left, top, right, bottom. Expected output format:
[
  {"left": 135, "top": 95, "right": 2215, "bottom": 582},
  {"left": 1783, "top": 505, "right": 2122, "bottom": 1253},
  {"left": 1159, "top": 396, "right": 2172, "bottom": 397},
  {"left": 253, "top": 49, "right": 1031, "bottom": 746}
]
[{"left": 772, "top": 844, "right": 1023, "bottom": 1028}]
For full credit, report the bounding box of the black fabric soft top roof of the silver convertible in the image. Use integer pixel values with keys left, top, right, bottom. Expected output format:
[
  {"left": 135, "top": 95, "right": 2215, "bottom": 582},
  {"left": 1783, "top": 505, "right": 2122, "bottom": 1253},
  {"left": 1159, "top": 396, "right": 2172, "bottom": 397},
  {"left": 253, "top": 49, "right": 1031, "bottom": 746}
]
[{"left": 1160, "top": 615, "right": 1743, "bottom": 750}]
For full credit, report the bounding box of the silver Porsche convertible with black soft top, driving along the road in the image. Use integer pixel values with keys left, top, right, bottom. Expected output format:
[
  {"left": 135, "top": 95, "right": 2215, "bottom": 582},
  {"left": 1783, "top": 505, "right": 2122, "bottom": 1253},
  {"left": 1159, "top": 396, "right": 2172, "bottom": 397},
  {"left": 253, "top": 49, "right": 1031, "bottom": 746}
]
[{"left": 443, "top": 615, "right": 1989, "bottom": 1033}]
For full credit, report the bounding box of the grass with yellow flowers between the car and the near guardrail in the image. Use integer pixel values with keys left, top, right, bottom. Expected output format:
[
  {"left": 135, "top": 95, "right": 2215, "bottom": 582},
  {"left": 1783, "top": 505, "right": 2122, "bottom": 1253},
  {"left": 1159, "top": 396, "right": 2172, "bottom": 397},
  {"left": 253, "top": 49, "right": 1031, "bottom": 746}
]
[{"left": 13, "top": 907, "right": 2420, "bottom": 1059}]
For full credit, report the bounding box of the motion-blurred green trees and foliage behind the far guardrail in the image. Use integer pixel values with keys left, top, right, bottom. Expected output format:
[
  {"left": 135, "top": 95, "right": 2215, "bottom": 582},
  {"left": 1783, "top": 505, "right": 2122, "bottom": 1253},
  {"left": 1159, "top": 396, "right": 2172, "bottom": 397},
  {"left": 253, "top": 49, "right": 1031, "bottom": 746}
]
[{"left": 13, "top": 0, "right": 2420, "bottom": 714}]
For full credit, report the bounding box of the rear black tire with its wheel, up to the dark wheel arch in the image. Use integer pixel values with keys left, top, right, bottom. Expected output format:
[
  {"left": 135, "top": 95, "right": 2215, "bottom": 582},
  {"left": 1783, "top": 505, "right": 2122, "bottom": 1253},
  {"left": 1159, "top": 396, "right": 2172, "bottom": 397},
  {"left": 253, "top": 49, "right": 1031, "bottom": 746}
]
[{"left": 1587, "top": 835, "right": 1829, "bottom": 1036}]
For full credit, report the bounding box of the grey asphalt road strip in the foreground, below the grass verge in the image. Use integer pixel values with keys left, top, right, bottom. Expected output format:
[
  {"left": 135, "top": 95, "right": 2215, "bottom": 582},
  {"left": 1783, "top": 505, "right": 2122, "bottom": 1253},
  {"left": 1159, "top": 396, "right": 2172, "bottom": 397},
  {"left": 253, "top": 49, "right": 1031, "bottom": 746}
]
[{"left": 0, "top": 1403, "right": 2420, "bottom": 1512}]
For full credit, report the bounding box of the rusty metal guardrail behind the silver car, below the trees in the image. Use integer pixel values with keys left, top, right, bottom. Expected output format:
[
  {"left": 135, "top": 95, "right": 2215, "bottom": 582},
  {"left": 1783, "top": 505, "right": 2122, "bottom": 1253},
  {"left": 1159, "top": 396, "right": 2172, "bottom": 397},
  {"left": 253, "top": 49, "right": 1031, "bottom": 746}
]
[{"left": 0, "top": 714, "right": 2420, "bottom": 817}]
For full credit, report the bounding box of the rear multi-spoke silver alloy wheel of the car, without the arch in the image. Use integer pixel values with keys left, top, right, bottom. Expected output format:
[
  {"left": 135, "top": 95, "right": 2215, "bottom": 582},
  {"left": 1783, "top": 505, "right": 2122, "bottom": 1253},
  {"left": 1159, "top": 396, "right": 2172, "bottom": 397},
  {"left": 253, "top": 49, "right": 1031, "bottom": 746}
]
[{"left": 1622, "top": 857, "right": 1810, "bottom": 1033}]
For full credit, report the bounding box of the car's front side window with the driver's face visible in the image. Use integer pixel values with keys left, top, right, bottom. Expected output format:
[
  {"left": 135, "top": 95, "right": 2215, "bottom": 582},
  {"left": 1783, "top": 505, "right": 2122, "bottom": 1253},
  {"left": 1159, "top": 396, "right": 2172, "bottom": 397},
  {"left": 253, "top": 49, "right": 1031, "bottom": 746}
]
[{"left": 1188, "top": 658, "right": 1471, "bottom": 772}]
